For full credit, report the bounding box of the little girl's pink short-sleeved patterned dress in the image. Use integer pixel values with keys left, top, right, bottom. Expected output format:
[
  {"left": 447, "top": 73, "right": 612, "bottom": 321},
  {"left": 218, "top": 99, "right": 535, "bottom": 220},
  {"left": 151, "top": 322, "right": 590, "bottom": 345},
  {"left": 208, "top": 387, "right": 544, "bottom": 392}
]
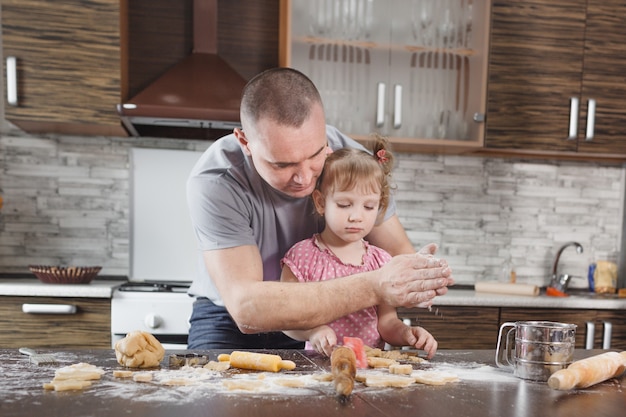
[{"left": 281, "top": 234, "right": 391, "bottom": 349}]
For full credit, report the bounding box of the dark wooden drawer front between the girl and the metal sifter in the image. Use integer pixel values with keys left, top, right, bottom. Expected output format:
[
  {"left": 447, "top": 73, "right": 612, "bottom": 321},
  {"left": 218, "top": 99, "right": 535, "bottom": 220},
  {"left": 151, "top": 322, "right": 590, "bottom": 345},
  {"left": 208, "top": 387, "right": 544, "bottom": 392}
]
[{"left": 398, "top": 306, "right": 500, "bottom": 349}]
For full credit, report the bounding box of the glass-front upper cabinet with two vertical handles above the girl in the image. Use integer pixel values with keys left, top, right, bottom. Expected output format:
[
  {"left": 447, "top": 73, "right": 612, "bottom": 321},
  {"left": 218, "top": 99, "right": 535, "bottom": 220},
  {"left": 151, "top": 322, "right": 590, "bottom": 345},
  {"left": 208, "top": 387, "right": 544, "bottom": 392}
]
[{"left": 280, "top": 0, "right": 490, "bottom": 151}]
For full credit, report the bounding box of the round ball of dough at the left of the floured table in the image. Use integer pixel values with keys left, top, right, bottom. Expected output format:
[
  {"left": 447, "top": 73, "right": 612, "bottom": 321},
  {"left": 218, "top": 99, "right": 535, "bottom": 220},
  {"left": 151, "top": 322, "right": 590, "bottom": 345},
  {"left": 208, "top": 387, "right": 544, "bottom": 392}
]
[{"left": 115, "top": 330, "right": 165, "bottom": 368}]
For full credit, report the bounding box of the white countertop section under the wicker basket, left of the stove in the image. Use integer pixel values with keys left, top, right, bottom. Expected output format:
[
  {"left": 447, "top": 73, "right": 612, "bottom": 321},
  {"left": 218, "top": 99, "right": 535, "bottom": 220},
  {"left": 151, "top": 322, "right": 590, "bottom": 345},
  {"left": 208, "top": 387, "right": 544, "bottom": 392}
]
[{"left": 0, "top": 278, "right": 126, "bottom": 298}]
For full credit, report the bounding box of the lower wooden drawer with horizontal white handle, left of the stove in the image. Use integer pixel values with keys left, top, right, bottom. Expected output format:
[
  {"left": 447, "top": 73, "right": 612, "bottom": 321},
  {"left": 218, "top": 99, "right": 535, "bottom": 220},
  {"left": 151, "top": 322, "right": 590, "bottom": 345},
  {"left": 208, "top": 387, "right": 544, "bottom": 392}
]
[{"left": 0, "top": 296, "right": 111, "bottom": 349}]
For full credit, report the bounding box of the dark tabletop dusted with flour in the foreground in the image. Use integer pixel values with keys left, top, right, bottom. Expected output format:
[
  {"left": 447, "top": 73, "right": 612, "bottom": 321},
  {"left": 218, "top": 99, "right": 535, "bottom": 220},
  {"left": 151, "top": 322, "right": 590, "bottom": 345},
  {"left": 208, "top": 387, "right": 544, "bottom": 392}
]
[{"left": 0, "top": 349, "right": 626, "bottom": 417}]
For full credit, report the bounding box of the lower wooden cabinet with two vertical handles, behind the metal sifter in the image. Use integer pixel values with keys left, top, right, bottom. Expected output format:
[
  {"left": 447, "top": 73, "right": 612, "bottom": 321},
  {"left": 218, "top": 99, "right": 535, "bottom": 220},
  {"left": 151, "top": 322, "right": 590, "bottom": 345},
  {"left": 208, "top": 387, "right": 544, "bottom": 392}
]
[{"left": 500, "top": 308, "right": 626, "bottom": 350}]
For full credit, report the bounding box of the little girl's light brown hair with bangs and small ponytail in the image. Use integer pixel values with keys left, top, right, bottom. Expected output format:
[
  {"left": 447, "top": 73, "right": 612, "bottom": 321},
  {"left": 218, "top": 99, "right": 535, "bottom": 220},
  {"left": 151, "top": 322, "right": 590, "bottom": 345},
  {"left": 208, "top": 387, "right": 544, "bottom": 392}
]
[{"left": 315, "top": 135, "right": 394, "bottom": 218}]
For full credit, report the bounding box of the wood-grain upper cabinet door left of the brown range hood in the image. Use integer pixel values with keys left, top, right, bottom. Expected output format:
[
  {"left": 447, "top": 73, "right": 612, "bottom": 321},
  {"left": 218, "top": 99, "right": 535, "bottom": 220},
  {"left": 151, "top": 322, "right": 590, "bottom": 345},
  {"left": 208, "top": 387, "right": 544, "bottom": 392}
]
[{"left": 1, "top": 0, "right": 123, "bottom": 134}]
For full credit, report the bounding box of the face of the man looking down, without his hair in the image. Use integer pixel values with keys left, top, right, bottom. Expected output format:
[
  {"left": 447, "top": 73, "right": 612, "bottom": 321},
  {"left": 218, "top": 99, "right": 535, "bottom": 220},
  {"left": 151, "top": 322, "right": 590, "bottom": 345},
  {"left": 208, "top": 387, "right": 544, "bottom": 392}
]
[{"left": 235, "top": 106, "right": 328, "bottom": 198}]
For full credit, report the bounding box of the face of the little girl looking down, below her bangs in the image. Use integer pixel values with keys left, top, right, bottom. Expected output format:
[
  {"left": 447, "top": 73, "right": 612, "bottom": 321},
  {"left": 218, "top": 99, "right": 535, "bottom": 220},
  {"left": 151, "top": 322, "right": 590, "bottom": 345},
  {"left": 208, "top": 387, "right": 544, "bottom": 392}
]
[{"left": 313, "top": 187, "right": 380, "bottom": 242}]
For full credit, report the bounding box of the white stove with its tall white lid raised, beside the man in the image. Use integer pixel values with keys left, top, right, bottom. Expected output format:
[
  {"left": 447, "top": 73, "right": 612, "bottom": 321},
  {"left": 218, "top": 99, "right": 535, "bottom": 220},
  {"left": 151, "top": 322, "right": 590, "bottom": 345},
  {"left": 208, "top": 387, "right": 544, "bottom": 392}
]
[{"left": 111, "top": 148, "right": 202, "bottom": 349}]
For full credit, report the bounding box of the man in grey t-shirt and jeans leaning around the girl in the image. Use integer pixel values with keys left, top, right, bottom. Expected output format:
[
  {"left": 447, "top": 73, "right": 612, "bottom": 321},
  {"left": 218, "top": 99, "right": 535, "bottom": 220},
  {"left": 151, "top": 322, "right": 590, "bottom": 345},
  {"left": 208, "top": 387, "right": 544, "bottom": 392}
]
[{"left": 187, "top": 68, "right": 453, "bottom": 349}]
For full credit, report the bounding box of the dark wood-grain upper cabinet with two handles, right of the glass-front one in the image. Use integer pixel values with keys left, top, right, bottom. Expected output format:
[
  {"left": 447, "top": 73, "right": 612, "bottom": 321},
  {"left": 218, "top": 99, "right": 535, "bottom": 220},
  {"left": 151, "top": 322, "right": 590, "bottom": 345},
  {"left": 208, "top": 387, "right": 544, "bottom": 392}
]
[{"left": 485, "top": 0, "right": 626, "bottom": 160}]
